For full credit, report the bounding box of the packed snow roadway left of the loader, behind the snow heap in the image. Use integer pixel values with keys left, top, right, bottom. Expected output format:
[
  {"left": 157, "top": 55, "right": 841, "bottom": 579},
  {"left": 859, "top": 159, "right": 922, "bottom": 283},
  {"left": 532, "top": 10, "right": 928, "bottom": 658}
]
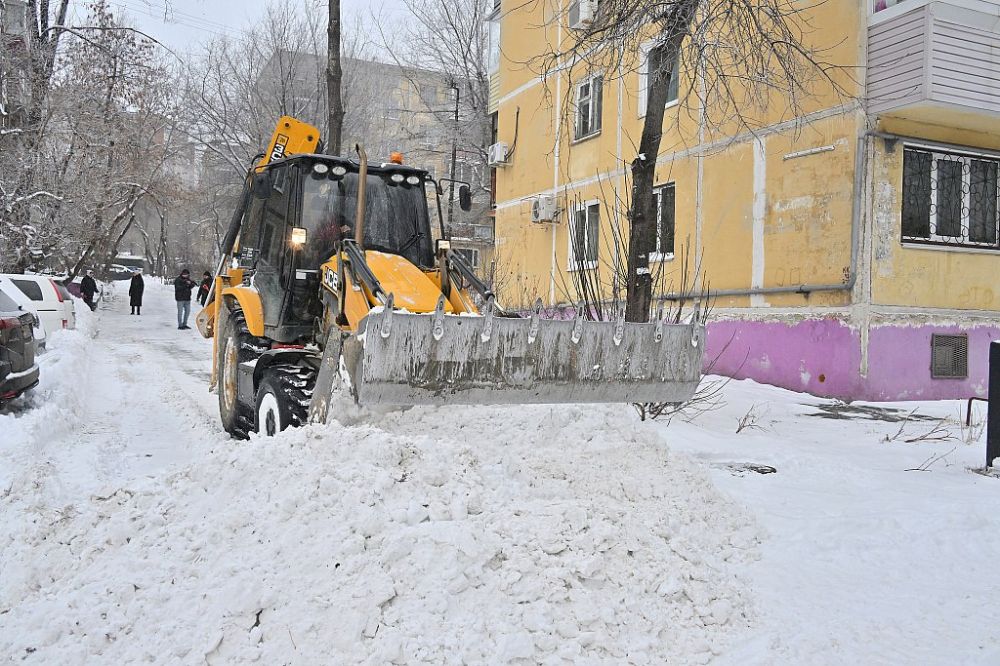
[{"left": 0, "top": 279, "right": 226, "bottom": 503}]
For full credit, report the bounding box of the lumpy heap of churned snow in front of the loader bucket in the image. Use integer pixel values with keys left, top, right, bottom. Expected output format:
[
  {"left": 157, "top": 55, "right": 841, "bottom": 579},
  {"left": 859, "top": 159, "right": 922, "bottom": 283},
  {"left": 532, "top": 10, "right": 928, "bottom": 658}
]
[{"left": 0, "top": 396, "right": 757, "bottom": 664}]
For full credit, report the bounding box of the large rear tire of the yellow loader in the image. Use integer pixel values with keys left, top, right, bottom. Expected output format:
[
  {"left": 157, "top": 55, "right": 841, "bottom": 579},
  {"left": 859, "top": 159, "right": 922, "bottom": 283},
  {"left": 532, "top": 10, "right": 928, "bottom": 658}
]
[{"left": 217, "top": 306, "right": 268, "bottom": 439}]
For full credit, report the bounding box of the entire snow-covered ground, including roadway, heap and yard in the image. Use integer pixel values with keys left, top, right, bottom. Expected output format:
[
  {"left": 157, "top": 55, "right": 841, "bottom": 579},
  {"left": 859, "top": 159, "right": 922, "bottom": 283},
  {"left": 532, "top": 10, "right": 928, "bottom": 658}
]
[{"left": 0, "top": 280, "right": 1000, "bottom": 664}]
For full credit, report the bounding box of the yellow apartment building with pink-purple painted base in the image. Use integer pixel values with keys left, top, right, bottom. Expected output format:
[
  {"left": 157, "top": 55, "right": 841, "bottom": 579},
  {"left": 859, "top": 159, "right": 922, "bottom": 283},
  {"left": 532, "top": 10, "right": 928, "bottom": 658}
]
[{"left": 491, "top": 0, "right": 1000, "bottom": 400}]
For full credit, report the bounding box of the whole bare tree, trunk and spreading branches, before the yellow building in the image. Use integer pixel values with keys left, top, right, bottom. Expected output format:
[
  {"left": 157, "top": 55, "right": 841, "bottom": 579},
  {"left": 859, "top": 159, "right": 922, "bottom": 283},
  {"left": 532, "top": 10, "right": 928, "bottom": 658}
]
[{"left": 536, "top": 0, "right": 847, "bottom": 321}]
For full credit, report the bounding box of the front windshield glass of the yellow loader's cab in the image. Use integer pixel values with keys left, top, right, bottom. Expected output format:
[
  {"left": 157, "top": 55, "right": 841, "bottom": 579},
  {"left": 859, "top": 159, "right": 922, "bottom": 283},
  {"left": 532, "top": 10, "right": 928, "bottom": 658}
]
[{"left": 302, "top": 173, "right": 434, "bottom": 268}]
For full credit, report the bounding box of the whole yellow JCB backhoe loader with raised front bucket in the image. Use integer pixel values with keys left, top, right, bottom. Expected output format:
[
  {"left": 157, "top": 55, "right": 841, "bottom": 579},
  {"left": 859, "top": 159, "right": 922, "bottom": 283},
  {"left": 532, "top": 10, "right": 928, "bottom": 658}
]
[{"left": 196, "top": 116, "right": 704, "bottom": 437}]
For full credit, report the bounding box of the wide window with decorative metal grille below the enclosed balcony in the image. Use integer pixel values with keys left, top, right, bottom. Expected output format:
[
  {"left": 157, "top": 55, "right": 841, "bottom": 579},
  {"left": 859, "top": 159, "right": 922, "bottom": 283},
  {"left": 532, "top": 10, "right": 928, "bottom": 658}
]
[{"left": 901, "top": 147, "right": 1000, "bottom": 249}]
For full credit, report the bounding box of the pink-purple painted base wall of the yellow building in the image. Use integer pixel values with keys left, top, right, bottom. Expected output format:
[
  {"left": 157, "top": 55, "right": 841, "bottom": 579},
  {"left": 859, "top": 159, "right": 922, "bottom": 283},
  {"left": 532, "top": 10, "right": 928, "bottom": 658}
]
[{"left": 705, "top": 317, "right": 1000, "bottom": 401}]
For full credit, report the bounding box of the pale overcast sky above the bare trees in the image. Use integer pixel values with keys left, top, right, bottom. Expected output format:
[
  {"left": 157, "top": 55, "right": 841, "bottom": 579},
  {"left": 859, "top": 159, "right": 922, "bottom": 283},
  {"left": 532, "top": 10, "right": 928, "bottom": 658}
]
[{"left": 97, "top": 0, "right": 398, "bottom": 52}]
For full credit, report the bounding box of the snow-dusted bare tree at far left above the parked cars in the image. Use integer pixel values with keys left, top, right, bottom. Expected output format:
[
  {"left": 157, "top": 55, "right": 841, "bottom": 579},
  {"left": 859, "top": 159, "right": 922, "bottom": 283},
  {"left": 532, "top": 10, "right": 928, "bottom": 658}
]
[{"left": 0, "top": 0, "right": 182, "bottom": 277}]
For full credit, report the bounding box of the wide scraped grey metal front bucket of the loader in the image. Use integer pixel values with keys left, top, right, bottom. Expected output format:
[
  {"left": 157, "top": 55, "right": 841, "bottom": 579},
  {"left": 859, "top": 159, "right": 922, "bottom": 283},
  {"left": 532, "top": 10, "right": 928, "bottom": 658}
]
[{"left": 342, "top": 300, "right": 705, "bottom": 405}]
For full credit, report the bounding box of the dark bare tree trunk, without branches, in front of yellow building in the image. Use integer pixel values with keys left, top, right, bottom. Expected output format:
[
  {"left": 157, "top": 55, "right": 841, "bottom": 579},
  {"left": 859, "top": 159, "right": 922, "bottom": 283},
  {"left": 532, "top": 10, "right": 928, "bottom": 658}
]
[{"left": 625, "top": 0, "right": 698, "bottom": 322}]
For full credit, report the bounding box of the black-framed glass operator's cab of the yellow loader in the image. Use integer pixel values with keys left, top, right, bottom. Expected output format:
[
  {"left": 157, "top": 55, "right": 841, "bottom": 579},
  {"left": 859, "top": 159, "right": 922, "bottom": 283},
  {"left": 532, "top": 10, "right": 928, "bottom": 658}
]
[{"left": 238, "top": 155, "right": 437, "bottom": 343}]
